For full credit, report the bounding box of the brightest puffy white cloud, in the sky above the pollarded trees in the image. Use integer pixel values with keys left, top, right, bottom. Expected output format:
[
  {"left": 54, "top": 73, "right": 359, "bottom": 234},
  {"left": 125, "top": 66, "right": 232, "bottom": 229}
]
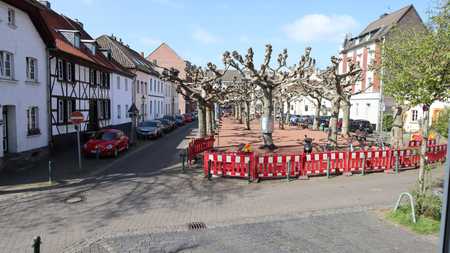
[{"left": 283, "top": 14, "right": 359, "bottom": 42}]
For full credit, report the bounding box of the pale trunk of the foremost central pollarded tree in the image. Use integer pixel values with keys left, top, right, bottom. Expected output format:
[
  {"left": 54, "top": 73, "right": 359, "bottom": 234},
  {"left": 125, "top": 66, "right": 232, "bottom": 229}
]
[{"left": 261, "top": 89, "right": 275, "bottom": 149}]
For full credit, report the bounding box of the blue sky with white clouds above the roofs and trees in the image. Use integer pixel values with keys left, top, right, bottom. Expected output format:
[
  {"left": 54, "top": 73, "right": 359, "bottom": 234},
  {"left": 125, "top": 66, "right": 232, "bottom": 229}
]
[{"left": 50, "top": 0, "right": 432, "bottom": 68}]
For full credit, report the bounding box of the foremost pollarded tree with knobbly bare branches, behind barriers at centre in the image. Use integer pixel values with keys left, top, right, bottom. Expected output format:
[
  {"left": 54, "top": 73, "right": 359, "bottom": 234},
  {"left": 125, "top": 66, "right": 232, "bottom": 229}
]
[{"left": 223, "top": 45, "right": 313, "bottom": 149}]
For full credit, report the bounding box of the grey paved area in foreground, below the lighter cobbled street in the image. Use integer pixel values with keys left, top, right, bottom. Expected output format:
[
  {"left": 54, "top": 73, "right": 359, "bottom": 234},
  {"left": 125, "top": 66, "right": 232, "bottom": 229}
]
[{"left": 83, "top": 211, "right": 437, "bottom": 253}]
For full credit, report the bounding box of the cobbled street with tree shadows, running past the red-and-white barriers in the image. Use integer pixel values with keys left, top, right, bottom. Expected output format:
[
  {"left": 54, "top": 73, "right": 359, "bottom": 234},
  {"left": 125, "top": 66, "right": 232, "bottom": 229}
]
[{"left": 0, "top": 123, "right": 442, "bottom": 253}]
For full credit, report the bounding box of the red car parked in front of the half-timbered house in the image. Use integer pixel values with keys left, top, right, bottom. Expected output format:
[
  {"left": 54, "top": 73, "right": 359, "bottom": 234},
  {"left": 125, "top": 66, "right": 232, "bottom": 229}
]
[{"left": 83, "top": 129, "right": 129, "bottom": 157}]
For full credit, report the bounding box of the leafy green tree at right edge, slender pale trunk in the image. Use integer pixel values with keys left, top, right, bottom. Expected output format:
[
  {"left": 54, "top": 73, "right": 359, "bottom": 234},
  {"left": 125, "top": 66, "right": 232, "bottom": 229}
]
[{"left": 380, "top": 3, "right": 450, "bottom": 194}]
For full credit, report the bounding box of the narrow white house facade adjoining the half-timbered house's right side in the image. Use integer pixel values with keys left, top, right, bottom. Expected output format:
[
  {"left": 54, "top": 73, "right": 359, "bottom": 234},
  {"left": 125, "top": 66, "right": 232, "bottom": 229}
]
[{"left": 111, "top": 73, "right": 134, "bottom": 125}]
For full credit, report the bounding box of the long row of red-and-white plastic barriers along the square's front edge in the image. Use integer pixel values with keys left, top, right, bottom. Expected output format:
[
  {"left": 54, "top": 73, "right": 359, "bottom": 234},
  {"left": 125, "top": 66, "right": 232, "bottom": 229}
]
[{"left": 203, "top": 145, "right": 447, "bottom": 180}]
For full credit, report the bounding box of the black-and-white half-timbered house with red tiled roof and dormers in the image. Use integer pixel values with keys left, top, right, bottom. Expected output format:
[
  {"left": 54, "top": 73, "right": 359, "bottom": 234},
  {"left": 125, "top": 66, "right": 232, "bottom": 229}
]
[{"left": 37, "top": 3, "right": 122, "bottom": 146}]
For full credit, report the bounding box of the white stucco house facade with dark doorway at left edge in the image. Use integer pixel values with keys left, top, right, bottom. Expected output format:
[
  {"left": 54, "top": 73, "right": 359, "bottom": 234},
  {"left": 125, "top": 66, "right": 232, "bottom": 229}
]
[{"left": 0, "top": 1, "right": 48, "bottom": 157}]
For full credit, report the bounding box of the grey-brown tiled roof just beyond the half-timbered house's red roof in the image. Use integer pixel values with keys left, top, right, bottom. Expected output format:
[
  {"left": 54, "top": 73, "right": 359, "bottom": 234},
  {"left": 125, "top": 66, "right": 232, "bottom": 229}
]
[{"left": 97, "top": 35, "right": 159, "bottom": 76}]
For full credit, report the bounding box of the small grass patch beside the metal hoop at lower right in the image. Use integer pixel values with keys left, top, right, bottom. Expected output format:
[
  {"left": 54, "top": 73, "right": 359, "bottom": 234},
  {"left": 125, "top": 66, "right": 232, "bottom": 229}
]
[{"left": 386, "top": 207, "right": 440, "bottom": 235}]
